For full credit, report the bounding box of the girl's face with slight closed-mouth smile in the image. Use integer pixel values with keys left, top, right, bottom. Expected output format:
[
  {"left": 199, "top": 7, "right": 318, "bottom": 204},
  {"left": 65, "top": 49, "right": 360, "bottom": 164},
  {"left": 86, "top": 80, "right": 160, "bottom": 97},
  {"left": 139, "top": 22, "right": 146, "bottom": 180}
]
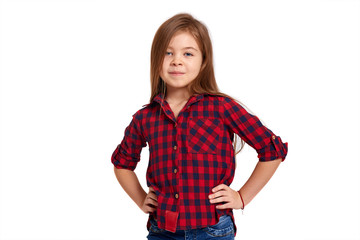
[{"left": 160, "top": 32, "right": 202, "bottom": 94}]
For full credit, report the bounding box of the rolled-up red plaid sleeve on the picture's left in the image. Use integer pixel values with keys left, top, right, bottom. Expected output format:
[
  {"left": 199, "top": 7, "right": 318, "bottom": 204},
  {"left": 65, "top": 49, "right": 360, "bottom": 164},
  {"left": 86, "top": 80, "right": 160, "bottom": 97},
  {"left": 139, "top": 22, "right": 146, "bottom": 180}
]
[{"left": 111, "top": 114, "right": 146, "bottom": 171}]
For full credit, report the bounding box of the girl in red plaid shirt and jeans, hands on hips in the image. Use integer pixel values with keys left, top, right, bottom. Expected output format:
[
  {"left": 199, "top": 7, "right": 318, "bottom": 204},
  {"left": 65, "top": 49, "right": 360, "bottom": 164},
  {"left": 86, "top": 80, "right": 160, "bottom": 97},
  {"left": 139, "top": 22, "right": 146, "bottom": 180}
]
[{"left": 111, "top": 14, "right": 288, "bottom": 239}]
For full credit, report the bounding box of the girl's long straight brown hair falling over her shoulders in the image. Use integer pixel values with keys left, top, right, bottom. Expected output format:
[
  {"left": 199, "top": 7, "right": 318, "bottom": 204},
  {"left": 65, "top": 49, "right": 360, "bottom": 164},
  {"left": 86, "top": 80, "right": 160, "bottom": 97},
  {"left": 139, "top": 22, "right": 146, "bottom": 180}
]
[{"left": 150, "top": 13, "right": 258, "bottom": 158}]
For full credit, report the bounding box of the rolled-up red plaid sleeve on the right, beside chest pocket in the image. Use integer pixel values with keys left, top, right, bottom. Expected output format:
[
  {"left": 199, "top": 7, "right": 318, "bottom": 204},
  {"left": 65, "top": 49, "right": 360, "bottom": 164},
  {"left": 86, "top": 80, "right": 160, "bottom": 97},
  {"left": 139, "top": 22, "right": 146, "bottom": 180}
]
[{"left": 222, "top": 97, "right": 288, "bottom": 162}]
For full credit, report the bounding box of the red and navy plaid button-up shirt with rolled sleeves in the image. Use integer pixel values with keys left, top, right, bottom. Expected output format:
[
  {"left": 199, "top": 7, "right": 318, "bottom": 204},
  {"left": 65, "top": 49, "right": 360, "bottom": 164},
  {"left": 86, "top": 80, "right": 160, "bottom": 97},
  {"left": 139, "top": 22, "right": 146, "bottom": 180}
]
[{"left": 111, "top": 93, "right": 288, "bottom": 234}]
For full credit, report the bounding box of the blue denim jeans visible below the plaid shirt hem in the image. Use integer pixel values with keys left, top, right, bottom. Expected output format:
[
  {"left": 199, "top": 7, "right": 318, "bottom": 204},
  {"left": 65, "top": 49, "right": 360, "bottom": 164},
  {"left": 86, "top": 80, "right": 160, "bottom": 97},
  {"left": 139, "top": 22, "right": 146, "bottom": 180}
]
[{"left": 147, "top": 215, "right": 235, "bottom": 240}]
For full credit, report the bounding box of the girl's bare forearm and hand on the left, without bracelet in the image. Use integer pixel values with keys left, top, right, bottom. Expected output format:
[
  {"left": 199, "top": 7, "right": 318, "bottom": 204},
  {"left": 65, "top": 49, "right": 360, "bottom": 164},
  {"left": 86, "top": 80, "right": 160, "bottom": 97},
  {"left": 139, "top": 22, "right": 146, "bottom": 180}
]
[{"left": 114, "top": 167, "right": 157, "bottom": 213}]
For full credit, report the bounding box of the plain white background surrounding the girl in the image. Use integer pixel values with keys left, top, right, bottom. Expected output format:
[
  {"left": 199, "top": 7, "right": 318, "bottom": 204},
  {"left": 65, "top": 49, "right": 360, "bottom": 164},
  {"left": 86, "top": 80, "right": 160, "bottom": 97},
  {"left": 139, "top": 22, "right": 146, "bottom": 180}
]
[{"left": 0, "top": 0, "right": 360, "bottom": 240}]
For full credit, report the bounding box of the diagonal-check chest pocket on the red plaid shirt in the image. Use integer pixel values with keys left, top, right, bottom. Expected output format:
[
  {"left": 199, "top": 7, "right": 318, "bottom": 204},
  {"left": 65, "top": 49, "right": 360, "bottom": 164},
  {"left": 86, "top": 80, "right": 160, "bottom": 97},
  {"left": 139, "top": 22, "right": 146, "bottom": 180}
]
[{"left": 187, "top": 118, "right": 220, "bottom": 154}]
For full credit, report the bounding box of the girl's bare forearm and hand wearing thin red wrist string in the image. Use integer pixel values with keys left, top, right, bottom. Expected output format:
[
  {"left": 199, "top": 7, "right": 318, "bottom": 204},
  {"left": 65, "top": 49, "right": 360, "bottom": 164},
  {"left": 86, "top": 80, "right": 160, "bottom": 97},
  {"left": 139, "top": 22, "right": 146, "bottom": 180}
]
[{"left": 209, "top": 158, "right": 281, "bottom": 209}]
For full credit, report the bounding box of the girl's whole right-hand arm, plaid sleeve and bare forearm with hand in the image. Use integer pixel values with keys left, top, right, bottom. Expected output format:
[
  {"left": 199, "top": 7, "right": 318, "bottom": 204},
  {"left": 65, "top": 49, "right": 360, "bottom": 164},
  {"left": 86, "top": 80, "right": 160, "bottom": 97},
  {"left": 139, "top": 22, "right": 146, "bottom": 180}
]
[{"left": 209, "top": 98, "right": 288, "bottom": 209}]
